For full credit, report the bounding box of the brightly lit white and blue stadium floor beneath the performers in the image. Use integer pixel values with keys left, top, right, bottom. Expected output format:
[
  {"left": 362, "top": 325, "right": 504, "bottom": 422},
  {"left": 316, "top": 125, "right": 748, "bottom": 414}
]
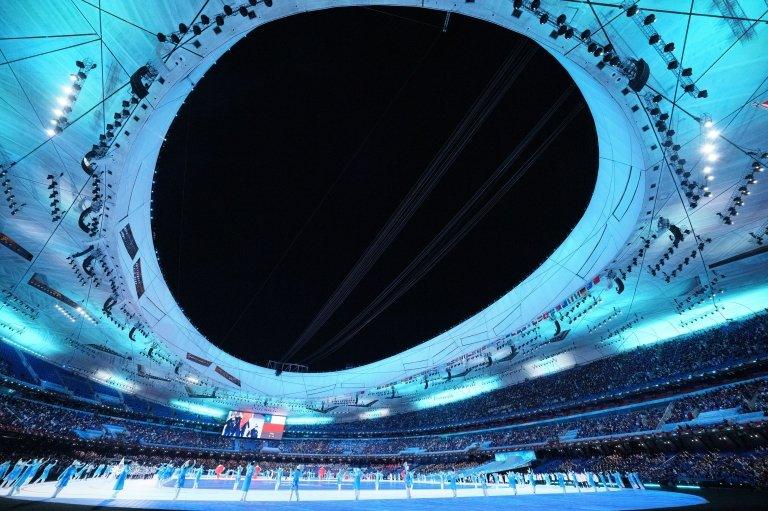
[{"left": 0, "top": 479, "right": 706, "bottom": 511}]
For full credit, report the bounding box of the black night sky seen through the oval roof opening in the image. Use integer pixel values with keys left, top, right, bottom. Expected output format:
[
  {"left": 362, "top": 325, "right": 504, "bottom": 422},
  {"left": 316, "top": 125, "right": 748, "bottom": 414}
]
[{"left": 154, "top": 8, "right": 597, "bottom": 371}]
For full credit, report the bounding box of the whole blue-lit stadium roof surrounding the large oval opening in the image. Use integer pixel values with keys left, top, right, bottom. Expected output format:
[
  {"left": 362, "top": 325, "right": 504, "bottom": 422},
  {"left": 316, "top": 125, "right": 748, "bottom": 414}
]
[{"left": 0, "top": 0, "right": 768, "bottom": 417}]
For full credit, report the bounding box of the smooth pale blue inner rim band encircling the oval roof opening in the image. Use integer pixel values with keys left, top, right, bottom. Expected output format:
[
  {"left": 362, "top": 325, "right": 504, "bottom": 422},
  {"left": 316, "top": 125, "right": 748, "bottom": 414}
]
[{"left": 110, "top": 1, "right": 648, "bottom": 399}]
